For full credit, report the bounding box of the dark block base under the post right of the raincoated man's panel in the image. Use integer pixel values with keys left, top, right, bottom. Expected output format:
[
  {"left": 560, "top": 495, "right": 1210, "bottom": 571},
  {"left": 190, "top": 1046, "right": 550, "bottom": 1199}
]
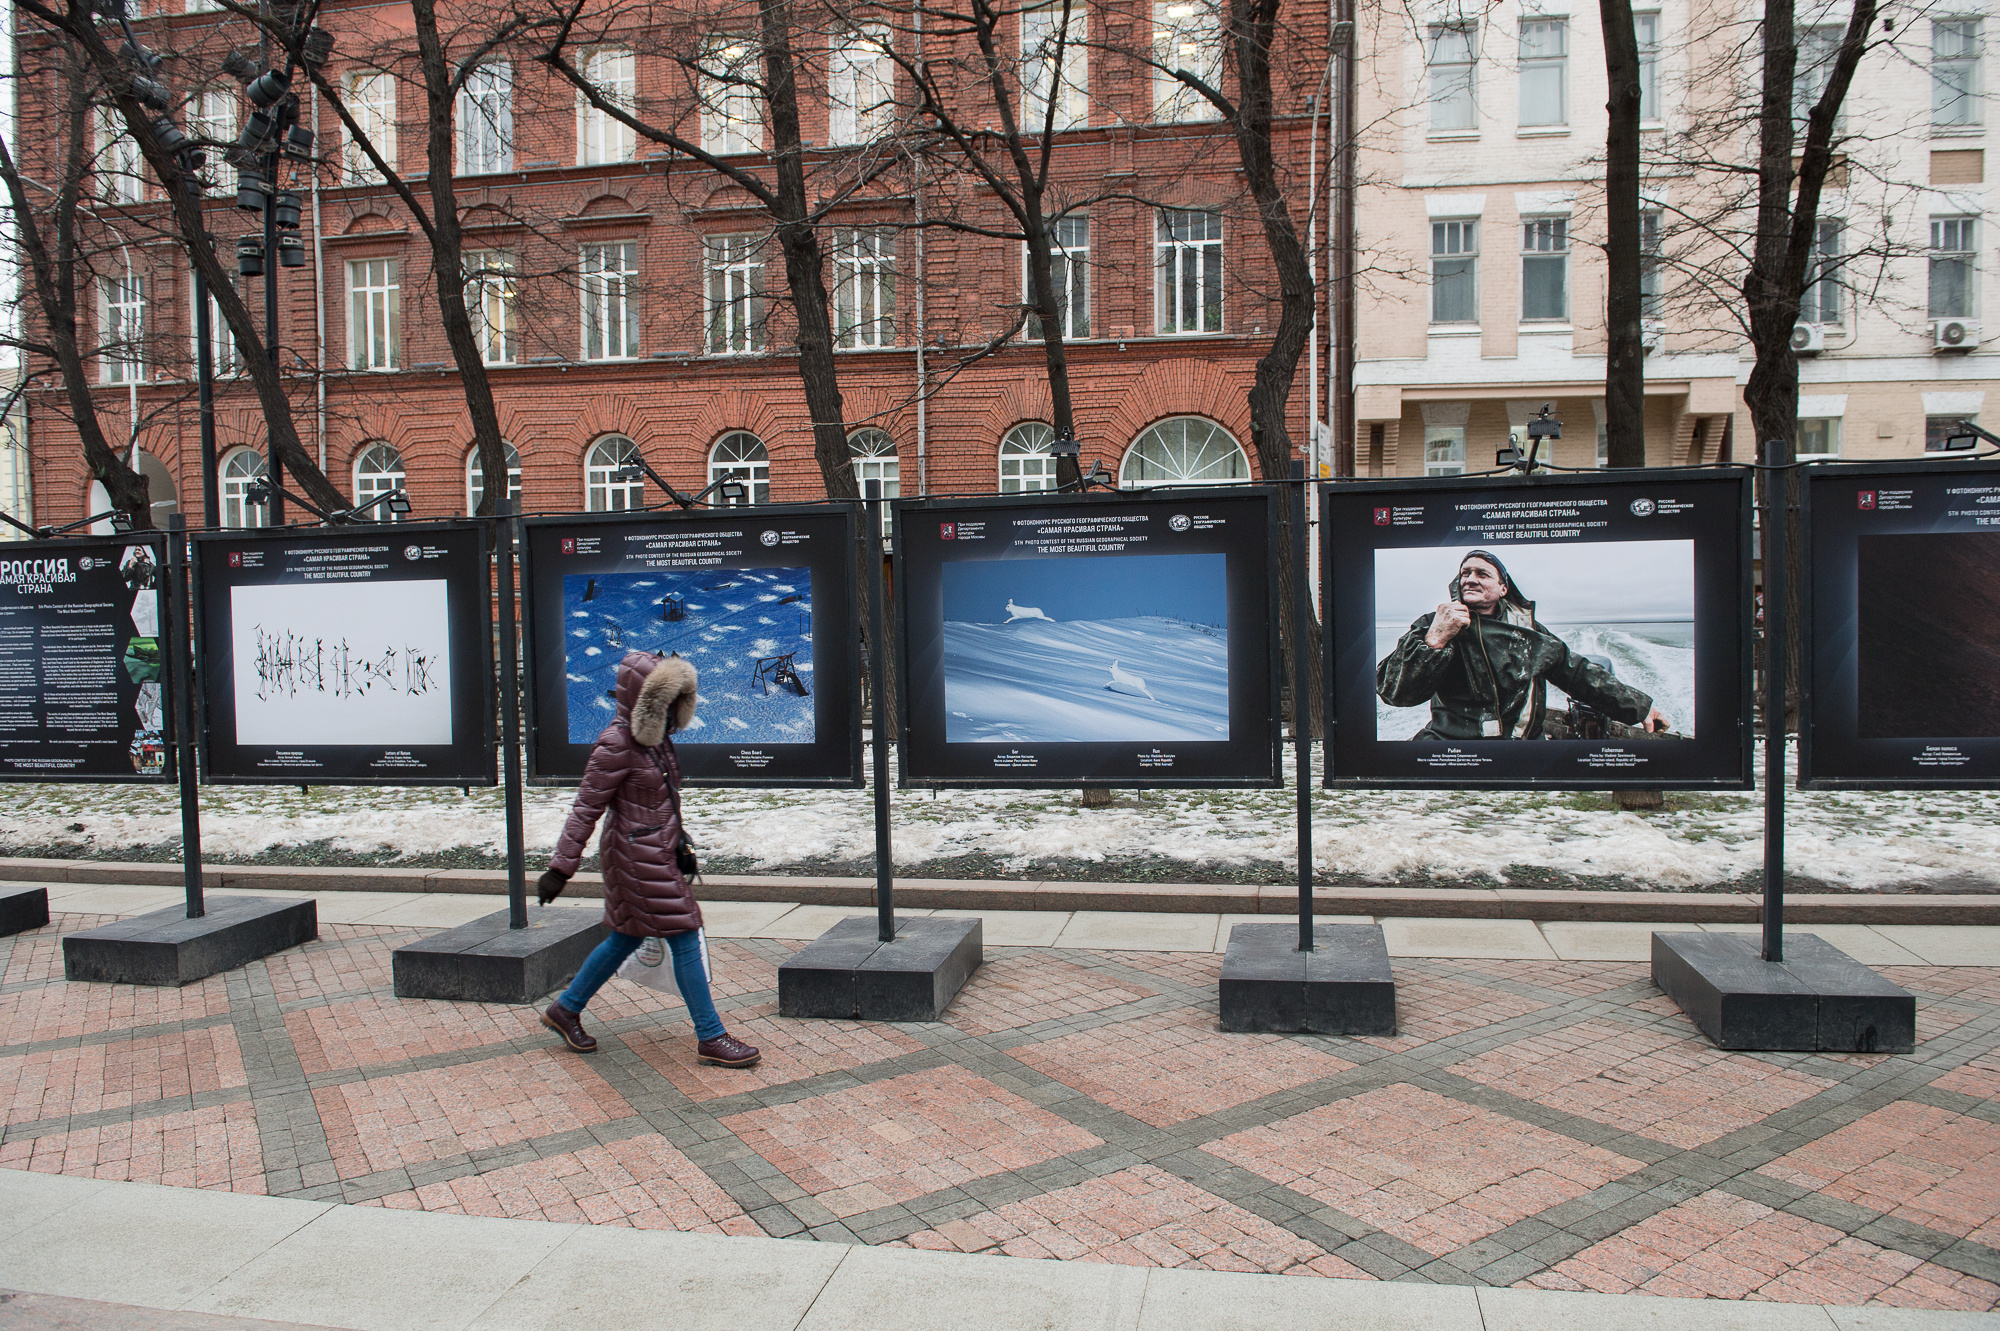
[{"left": 1652, "top": 933, "right": 1916, "bottom": 1053}]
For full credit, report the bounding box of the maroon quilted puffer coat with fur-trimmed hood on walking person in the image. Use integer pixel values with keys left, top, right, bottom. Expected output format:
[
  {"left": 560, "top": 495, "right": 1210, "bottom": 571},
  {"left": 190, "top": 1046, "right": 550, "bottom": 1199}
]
[{"left": 548, "top": 652, "right": 702, "bottom": 937}]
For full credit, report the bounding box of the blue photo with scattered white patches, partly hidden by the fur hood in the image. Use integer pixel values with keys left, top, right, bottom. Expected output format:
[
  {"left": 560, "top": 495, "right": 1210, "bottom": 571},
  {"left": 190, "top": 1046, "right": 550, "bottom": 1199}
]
[{"left": 562, "top": 568, "right": 814, "bottom": 743}]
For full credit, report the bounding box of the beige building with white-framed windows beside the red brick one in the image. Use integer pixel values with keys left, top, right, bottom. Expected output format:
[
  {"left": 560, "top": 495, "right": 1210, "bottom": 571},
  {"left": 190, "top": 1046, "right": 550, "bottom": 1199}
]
[{"left": 1354, "top": 0, "right": 2000, "bottom": 476}]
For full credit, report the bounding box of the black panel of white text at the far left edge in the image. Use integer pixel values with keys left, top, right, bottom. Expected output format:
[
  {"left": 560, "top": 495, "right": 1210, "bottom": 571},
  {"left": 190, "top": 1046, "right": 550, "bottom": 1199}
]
[{"left": 0, "top": 534, "right": 174, "bottom": 781}]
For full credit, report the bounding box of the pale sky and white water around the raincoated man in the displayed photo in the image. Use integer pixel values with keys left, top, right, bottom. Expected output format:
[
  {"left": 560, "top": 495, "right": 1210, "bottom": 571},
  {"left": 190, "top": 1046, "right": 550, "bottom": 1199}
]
[{"left": 1374, "top": 542, "right": 1694, "bottom": 739}]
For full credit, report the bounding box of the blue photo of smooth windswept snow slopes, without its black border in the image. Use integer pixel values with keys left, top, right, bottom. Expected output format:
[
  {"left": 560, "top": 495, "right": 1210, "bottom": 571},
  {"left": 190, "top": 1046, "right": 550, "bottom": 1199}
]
[{"left": 944, "top": 554, "right": 1230, "bottom": 743}]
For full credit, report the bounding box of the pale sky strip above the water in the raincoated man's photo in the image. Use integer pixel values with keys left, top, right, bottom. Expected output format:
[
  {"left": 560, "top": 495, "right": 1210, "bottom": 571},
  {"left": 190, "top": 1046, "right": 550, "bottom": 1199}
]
[{"left": 1376, "top": 542, "right": 1694, "bottom": 628}]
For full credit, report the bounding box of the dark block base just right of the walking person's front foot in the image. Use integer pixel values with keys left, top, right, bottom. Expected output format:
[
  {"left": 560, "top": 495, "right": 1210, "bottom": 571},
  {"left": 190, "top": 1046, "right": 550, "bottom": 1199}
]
[{"left": 778, "top": 915, "right": 984, "bottom": 1021}]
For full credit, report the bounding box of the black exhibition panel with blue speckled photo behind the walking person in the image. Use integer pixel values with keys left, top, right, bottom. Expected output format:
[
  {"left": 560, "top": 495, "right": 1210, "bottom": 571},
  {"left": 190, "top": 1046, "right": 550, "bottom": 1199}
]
[{"left": 522, "top": 504, "right": 862, "bottom": 785}]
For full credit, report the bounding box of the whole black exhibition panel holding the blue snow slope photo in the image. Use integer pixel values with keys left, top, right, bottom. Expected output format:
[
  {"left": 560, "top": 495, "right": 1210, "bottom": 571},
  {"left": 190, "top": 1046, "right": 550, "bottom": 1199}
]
[{"left": 896, "top": 486, "right": 1280, "bottom": 787}]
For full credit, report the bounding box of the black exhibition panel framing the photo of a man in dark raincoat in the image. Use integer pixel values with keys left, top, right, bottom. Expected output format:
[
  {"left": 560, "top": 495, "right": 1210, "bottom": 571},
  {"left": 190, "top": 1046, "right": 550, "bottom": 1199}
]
[{"left": 1320, "top": 468, "right": 1752, "bottom": 789}]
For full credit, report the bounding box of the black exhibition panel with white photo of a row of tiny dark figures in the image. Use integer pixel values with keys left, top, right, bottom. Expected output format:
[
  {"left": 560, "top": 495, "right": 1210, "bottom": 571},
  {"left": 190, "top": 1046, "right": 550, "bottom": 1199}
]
[{"left": 192, "top": 522, "right": 494, "bottom": 785}]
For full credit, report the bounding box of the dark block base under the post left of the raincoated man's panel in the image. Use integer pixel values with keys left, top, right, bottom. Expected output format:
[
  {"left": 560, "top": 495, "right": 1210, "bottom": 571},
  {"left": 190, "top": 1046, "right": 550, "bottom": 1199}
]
[{"left": 1222, "top": 921, "right": 1396, "bottom": 1035}]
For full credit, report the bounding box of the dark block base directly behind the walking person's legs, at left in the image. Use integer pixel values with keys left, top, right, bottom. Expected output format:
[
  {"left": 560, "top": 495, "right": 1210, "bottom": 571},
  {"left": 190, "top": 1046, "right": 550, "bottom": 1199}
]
[{"left": 390, "top": 907, "right": 610, "bottom": 1003}]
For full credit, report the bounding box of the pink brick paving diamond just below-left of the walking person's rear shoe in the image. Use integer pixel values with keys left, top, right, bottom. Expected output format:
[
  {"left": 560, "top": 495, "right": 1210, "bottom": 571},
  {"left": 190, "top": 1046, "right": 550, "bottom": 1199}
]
[{"left": 312, "top": 1049, "right": 630, "bottom": 1179}]
